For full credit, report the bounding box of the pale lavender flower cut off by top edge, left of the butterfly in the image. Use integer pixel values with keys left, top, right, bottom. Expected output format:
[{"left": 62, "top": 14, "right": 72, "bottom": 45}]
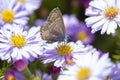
[{"left": 16, "top": 0, "right": 42, "bottom": 14}]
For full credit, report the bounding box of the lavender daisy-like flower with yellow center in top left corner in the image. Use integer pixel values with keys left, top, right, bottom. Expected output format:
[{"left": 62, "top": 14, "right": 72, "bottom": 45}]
[{"left": 0, "top": 0, "right": 29, "bottom": 25}]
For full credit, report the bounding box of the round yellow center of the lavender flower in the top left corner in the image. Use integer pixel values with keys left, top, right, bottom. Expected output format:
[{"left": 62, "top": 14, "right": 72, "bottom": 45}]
[{"left": 1, "top": 9, "right": 14, "bottom": 23}]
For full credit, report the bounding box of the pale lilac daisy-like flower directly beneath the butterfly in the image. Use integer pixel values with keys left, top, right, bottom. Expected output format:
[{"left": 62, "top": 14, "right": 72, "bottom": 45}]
[{"left": 40, "top": 41, "right": 93, "bottom": 67}]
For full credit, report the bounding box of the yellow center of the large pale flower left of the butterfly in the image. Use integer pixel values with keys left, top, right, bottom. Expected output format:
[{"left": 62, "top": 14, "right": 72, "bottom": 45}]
[{"left": 10, "top": 35, "right": 26, "bottom": 48}]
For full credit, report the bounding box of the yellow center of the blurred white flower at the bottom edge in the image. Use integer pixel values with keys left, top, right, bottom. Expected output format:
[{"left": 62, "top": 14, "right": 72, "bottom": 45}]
[{"left": 77, "top": 67, "right": 91, "bottom": 80}]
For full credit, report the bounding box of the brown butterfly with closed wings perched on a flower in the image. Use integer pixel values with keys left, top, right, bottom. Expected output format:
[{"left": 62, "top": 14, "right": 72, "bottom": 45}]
[{"left": 40, "top": 7, "right": 66, "bottom": 42}]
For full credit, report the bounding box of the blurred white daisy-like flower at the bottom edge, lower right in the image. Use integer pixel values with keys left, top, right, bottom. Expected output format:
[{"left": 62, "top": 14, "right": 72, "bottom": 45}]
[{"left": 57, "top": 51, "right": 111, "bottom": 80}]
